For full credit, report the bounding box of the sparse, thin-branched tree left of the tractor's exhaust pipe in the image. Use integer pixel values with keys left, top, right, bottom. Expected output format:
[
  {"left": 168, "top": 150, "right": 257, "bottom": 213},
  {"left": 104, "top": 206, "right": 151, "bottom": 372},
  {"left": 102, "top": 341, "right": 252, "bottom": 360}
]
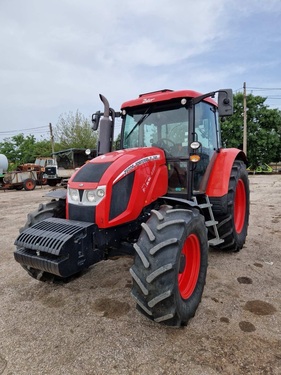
[{"left": 54, "top": 110, "right": 97, "bottom": 151}]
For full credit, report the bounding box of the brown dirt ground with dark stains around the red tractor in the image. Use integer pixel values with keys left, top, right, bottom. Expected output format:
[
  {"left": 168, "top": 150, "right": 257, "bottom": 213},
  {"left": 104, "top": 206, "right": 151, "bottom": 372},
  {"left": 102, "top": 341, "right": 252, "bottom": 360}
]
[{"left": 0, "top": 175, "right": 281, "bottom": 375}]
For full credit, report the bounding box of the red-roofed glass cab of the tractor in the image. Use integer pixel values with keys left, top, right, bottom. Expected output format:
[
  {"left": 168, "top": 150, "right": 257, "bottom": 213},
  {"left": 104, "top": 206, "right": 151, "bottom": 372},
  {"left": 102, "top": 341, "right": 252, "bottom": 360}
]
[{"left": 118, "top": 90, "right": 231, "bottom": 199}]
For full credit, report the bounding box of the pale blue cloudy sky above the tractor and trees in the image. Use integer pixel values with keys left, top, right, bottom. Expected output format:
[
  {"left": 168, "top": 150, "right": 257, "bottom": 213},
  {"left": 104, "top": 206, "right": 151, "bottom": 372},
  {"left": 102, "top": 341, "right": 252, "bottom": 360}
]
[{"left": 0, "top": 0, "right": 281, "bottom": 142}]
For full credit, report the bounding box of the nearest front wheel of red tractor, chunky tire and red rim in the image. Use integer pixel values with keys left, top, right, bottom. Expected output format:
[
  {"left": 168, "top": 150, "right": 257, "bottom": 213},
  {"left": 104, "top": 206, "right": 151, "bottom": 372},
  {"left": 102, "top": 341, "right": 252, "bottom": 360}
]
[{"left": 130, "top": 206, "right": 208, "bottom": 327}]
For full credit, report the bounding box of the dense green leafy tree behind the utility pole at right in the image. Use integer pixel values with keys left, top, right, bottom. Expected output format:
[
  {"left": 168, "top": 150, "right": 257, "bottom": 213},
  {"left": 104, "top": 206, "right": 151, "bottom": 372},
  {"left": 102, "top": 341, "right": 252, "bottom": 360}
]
[{"left": 221, "top": 93, "right": 281, "bottom": 168}]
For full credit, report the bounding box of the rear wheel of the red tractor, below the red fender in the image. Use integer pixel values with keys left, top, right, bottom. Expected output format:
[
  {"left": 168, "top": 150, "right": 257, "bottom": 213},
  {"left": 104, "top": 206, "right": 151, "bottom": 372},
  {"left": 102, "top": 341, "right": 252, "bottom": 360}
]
[{"left": 210, "top": 160, "right": 250, "bottom": 252}]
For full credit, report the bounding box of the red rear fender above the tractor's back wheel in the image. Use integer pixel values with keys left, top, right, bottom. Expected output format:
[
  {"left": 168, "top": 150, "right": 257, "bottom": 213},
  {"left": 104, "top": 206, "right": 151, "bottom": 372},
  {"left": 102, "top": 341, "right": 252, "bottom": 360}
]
[{"left": 206, "top": 148, "right": 247, "bottom": 197}]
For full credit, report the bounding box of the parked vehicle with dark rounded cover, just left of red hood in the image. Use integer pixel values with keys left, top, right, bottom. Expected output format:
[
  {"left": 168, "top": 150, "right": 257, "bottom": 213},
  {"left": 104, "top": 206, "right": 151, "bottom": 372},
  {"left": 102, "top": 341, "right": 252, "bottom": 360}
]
[{"left": 43, "top": 148, "right": 95, "bottom": 186}]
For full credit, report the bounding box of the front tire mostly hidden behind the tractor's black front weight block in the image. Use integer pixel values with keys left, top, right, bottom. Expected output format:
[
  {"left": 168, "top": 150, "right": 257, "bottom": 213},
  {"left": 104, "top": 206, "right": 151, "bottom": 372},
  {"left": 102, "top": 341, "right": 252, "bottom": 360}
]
[{"left": 20, "top": 200, "right": 67, "bottom": 282}]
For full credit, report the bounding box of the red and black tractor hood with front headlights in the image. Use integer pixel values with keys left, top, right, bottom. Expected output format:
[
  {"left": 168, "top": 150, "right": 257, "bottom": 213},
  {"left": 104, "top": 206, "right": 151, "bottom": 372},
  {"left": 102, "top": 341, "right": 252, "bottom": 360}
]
[{"left": 67, "top": 147, "right": 168, "bottom": 228}]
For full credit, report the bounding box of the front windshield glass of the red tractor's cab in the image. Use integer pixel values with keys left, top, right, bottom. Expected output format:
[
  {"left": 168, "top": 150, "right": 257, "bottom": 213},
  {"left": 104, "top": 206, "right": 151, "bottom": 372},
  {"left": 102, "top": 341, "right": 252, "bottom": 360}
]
[{"left": 123, "top": 106, "right": 188, "bottom": 157}]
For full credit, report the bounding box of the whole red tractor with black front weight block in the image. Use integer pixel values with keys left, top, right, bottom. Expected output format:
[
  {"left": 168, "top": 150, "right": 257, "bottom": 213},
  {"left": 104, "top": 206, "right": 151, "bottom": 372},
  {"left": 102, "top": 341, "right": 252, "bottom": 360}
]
[{"left": 14, "top": 89, "right": 249, "bottom": 326}]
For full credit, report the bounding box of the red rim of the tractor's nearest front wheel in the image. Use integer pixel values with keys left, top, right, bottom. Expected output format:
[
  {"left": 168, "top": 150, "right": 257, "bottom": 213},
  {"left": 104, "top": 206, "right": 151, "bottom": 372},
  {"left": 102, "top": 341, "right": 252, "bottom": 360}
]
[{"left": 178, "top": 234, "right": 201, "bottom": 299}]
